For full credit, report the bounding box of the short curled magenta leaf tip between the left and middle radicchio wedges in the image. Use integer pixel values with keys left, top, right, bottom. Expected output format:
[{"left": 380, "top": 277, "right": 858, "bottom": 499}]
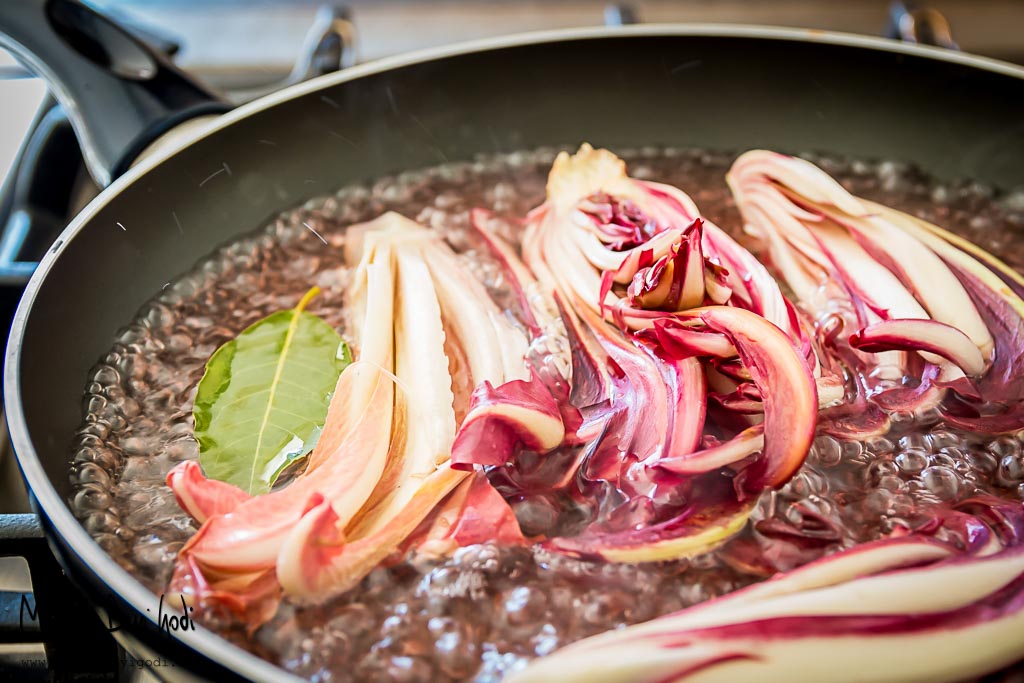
[{"left": 452, "top": 377, "right": 565, "bottom": 470}]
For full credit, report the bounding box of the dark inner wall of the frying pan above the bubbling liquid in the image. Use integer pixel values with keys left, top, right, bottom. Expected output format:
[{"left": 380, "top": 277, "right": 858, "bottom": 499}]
[{"left": 7, "top": 31, "right": 1024, "bottom": 683}]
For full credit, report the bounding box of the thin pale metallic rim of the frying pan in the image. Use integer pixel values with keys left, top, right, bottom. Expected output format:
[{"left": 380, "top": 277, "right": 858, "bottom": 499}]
[{"left": 3, "top": 24, "right": 1024, "bottom": 681}]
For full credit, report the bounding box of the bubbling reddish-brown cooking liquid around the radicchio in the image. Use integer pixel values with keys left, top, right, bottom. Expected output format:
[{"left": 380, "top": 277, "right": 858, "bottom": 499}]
[{"left": 71, "top": 150, "right": 1024, "bottom": 683}]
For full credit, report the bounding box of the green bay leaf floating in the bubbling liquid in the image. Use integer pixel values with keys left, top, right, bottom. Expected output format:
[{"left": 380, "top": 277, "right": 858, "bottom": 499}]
[{"left": 193, "top": 287, "right": 352, "bottom": 495}]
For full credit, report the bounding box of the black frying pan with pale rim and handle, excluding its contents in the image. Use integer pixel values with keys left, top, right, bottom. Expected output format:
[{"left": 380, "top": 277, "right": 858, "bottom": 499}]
[{"left": 0, "top": 0, "right": 1024, "bottom": 681}]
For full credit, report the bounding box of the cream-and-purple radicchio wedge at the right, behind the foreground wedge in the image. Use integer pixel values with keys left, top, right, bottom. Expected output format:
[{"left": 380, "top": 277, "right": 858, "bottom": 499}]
[{"left": 728, "top": 152, "right": 1024, "bottom": 434}]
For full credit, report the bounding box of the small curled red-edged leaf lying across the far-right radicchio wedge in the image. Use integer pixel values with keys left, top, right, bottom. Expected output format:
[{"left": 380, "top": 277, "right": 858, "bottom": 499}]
[{"left": 850, "top": 318, "right": 986, "bottom": 377}]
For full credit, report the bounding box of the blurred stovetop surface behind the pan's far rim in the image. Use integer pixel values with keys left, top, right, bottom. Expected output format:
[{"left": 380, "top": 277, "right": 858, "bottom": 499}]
[{"left": 61, "top": 0, "right": 1024, "bottom": 71}]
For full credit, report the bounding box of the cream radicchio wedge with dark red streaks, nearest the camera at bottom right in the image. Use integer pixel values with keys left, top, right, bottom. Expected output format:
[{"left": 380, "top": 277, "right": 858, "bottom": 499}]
[{"left": 509, "top": 538, "right": 1024, "bottom": 683}]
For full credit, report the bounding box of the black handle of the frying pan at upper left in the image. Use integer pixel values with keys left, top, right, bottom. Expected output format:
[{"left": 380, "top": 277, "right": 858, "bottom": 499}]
[{"left": 0, "top": 0, "right": 230, "bottom": 187}]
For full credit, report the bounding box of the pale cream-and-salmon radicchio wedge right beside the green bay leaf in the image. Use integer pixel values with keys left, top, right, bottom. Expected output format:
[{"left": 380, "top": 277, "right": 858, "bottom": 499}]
[{"left": 170, "top": 214, "right": 544, "bottom": 614}]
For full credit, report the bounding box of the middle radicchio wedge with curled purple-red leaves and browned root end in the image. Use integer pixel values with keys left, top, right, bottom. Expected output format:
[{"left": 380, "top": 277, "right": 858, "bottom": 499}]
[{"left": 523, "top": 145, "right": 823, "bottom": 561}]
